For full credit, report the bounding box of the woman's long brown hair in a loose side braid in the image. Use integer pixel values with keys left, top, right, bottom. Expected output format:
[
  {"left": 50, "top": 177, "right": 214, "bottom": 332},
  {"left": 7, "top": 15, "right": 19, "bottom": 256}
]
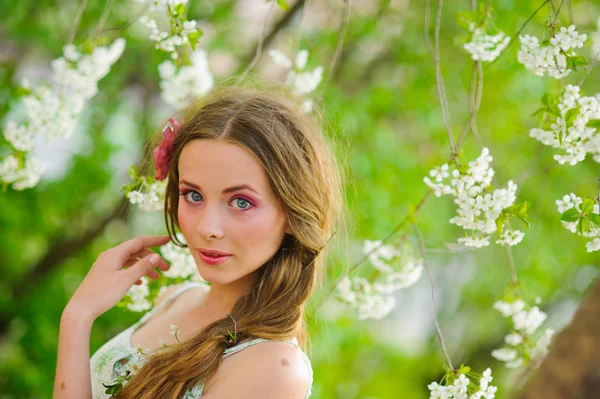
[{"left": 117, "top": 88, "right": 343, "bottom": 399}]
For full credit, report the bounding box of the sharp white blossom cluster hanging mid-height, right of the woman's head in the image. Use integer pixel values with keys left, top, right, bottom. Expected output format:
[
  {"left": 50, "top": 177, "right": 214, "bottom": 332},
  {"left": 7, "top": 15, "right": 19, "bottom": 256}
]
[{"left": 423, "top": 148, "right": 527, "bottom": 248}]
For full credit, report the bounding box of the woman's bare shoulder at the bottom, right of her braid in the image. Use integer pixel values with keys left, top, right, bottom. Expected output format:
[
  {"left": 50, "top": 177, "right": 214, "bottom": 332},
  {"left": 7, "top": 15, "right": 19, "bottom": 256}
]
[{"left": 205, "top": 341, "right": 312, "bottom": 399}]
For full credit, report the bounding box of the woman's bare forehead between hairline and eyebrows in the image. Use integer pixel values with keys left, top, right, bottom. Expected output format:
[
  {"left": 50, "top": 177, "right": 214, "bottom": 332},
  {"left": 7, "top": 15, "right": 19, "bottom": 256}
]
[{"left": 178, "top": 139, "right": 269, "bottom": 190}]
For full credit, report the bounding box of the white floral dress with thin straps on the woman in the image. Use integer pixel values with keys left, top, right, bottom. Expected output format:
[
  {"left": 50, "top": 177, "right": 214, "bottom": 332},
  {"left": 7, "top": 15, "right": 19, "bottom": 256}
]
[{"left": 90, "top": 282, "right": 313, "bottom": 399}]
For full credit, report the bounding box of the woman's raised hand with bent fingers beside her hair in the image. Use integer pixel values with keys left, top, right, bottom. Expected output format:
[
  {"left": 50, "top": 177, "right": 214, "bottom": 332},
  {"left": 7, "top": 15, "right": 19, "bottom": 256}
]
[{"left": 67, "top": 236, "right": 170, "bottom": 321}]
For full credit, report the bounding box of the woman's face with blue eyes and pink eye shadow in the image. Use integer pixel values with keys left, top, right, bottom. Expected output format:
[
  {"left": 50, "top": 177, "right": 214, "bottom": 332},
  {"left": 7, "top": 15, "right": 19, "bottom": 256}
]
[{"left": 177, "top": 139, "right": 291, "bottom": 285}]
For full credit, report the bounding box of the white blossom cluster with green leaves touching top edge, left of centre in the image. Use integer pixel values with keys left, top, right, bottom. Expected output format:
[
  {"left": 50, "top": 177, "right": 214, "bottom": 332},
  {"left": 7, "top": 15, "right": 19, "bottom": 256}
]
[{"left": 135, "top": 0, "right": 202, "bottom": 59}]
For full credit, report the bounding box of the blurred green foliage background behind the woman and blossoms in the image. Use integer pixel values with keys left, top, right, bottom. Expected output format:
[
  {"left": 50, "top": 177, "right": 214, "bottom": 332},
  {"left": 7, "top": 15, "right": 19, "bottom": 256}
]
[{"left": 0, "top": 0, "right": 600, "bottom": 399}]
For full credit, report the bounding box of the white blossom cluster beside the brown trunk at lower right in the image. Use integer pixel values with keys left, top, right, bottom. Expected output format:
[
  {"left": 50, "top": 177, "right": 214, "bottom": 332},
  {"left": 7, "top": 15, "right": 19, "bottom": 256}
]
[{"left": 492, "top": 299, "right": 554, "bottom": 368}]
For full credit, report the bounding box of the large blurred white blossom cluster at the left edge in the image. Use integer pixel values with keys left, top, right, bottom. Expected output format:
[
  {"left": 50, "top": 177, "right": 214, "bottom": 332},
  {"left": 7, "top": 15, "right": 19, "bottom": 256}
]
[{"left": 0, "top": 38, "right": 125, "bottom": 190}]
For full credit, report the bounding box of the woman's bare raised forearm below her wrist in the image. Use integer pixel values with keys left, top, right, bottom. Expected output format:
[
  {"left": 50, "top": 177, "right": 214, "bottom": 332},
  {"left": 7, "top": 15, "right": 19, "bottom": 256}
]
[{"left": 52, "top": 304, "right": 94, "bottom": 399}]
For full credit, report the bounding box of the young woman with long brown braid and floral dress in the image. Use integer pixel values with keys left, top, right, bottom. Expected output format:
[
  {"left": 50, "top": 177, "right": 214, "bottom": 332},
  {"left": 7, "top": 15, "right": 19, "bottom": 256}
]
[{"left": 54, "top": 89, "right": 342, "bottom": 399}]
